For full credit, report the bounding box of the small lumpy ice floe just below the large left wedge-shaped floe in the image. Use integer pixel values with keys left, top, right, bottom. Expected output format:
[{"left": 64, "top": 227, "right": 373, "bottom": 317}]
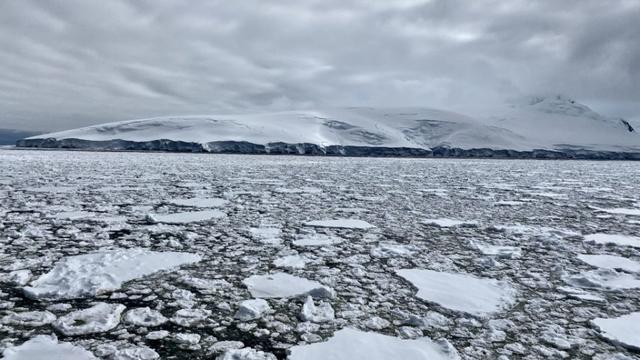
[{"left": 53, "top": 303, "right": 126, "bottom": 336}]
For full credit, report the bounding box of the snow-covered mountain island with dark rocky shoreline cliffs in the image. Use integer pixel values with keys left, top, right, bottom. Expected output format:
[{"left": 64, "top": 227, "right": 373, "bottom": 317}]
[{"left": 18, "top": 96, "right": 640, "bottom": 156}]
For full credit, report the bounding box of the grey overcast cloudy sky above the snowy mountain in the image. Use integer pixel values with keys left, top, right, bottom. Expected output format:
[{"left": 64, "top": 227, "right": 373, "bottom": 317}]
[{"left": 0, "top": 0, "right": 640, "bottom": 131}]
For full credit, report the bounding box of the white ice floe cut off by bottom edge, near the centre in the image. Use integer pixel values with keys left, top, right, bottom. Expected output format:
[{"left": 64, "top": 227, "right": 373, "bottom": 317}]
[{"left": 288, "top": 328, "right": 460, "bottom": 360}]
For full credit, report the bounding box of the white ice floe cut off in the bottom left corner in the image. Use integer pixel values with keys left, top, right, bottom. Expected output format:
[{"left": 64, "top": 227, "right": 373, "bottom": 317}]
[{"left": 2, "top": 335, "right": 98, "bottom": 360}]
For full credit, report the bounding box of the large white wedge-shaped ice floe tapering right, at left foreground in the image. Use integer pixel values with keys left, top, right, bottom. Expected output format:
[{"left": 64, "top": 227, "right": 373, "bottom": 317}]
[{"left": 24, "top": 248, "right": 201, "bottom": 299}]
